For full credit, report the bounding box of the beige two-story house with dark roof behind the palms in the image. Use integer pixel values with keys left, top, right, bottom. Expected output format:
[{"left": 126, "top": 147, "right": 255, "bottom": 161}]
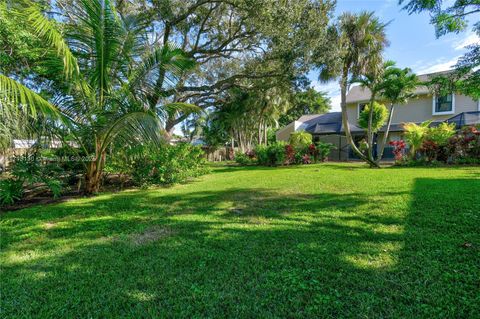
[{"left": 277, "top": 74, "right": 480, "bottom": 160}]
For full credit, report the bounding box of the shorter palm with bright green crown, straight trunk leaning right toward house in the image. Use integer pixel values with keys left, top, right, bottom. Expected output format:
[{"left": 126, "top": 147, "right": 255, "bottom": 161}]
[{"left": 377, "top": 65, "right": 419, "bottom": 163}]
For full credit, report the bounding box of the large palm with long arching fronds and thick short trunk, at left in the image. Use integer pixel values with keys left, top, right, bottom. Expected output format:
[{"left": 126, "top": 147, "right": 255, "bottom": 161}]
[{"left": 0, "top": 0, "right": 193, "bottom": 193}]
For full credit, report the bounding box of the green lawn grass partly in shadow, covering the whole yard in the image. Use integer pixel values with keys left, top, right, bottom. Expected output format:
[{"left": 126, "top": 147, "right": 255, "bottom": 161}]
[{"left": 0, "top": 164, "right": 480, "bottom": 318}]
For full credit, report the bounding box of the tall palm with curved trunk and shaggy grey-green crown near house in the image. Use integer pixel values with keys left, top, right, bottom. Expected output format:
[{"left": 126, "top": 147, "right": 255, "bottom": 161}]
[{"left": 320, "top": 12, "right": 388, "bottom": 166}]
